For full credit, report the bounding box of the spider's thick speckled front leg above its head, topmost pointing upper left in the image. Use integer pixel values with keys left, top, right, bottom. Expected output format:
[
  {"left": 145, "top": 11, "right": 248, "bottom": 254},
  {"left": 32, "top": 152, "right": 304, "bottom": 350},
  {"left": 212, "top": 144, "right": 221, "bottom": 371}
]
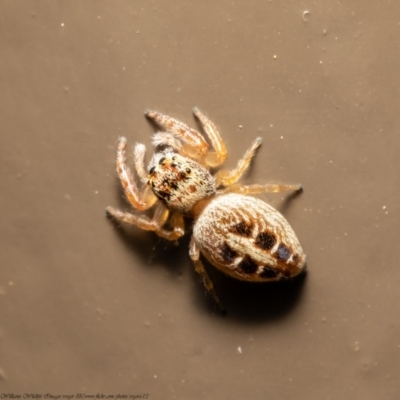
[{"left": 145, "top": 110, "right": 208, "bottom": 160}]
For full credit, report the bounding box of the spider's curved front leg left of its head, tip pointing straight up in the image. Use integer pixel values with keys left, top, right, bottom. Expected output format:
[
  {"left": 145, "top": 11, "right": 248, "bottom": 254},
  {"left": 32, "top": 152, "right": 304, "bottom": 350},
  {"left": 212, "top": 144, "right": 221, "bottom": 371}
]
[{"left": 116, "top": 136, "right": 157, "bottom": 211}]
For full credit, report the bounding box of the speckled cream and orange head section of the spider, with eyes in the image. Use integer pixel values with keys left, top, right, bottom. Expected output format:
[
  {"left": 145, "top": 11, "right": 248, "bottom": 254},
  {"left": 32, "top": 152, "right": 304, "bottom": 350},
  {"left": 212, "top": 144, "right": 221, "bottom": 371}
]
[{"left": 147, "top": 149, "right": 216, "bottom": 213}]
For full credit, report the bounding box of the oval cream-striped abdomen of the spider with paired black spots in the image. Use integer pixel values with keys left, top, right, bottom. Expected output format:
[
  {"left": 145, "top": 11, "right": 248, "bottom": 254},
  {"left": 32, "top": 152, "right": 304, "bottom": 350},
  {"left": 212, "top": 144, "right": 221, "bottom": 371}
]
[{"left": 193, "top": 194, "right": 305, "bottom": 281}]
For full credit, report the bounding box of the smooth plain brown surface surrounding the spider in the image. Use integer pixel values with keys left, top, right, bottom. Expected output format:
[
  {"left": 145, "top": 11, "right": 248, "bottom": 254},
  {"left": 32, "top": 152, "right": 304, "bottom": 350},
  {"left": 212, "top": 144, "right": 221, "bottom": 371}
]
[{"left": 0, "top": 0, "right": 400, "bottom": 400}]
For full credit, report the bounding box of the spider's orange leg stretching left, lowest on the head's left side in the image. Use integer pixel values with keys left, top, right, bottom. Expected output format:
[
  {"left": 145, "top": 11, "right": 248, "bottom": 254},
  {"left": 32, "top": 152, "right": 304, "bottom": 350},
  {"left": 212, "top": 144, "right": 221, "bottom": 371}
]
[{"left": 106, "top": 203, "right": 185, "bottom": 240}]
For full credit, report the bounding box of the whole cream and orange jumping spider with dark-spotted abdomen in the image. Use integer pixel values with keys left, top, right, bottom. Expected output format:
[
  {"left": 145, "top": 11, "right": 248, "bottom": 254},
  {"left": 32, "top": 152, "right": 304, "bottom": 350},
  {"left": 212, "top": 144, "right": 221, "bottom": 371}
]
[{"left": 106, "top": 107, "right": 305, "bottom": 310}]
